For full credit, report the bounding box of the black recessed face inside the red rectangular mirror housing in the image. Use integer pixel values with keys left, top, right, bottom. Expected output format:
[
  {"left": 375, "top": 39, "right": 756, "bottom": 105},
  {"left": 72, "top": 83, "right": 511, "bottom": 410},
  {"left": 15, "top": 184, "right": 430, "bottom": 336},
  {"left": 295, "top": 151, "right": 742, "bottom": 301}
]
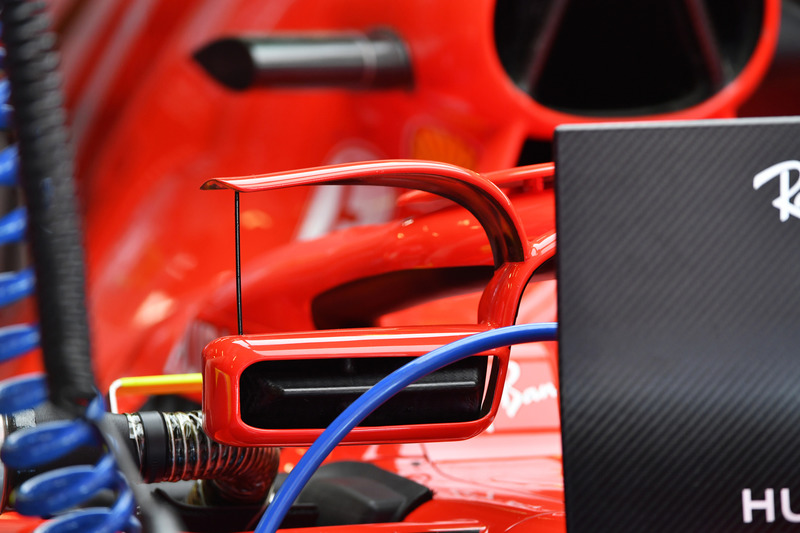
[{"left": 239, "top": 356, "right": 488, "bottom": 430}]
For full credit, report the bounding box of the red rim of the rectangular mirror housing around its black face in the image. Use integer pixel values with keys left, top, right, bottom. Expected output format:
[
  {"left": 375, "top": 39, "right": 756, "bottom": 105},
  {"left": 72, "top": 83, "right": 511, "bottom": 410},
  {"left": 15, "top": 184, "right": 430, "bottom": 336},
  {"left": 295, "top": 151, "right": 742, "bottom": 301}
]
[{"left": 203, "top": 326, "right": 500, "bottom": 446}]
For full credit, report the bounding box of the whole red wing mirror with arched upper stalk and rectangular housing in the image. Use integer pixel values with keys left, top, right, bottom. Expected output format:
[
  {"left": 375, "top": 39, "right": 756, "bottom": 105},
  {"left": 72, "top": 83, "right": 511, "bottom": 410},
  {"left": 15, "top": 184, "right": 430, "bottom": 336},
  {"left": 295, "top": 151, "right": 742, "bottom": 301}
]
[{"left": 198, "top": 161, "right": 555, "bottom": 446}]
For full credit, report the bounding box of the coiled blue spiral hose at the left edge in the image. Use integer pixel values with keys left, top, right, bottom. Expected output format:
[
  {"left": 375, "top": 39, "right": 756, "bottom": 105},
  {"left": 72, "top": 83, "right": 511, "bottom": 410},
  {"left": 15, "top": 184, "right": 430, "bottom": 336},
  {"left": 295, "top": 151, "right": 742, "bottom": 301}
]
[{"left": 0, "top": 11, "right": 141, "bottom": 533}]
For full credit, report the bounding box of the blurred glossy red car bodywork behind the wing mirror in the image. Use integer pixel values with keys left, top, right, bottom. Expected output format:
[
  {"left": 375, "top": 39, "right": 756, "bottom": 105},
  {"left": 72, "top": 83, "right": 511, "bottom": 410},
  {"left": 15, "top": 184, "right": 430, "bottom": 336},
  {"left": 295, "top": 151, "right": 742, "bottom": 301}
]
[{"left": 0, "top": 0, "right": 792, "bottom": 532}]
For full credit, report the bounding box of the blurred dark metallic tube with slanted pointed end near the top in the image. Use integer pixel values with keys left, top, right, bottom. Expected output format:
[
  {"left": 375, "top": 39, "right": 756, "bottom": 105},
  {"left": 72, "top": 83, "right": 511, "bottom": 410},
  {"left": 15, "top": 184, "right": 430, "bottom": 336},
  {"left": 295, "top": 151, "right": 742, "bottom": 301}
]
[{"left": 194, "top": 31, "right": 412, "bottom": 90}]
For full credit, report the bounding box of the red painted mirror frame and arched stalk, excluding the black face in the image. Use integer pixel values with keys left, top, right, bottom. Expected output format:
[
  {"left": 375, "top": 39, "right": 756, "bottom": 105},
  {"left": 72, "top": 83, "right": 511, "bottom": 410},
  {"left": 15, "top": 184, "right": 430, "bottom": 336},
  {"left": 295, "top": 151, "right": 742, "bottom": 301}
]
[{"left": 203, "top": 161, "right": 555, "bottom": 446}]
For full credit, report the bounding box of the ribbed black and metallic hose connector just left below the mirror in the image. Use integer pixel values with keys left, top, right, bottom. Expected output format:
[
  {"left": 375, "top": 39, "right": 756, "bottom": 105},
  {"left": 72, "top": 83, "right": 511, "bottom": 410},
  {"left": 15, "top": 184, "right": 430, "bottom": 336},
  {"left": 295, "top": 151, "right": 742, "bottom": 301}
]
[{"left": 126, "top": 411, "right": 280, "bottom": 504}]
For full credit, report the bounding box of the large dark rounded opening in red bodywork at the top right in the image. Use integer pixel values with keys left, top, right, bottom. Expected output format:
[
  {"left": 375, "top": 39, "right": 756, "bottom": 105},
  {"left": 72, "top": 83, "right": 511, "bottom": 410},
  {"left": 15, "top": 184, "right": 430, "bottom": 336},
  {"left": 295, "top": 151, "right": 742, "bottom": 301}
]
[{"left": 495, "top": 0, "right": 764, "bottom": 116}]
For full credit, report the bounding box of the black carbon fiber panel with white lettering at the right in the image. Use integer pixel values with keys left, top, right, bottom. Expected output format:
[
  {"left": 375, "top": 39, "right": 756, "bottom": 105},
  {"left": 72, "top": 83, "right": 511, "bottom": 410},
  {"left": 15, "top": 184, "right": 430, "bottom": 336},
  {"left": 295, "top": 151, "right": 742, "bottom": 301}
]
[{"left": 556, "top": 118, "right": 800, "bottom": 533}]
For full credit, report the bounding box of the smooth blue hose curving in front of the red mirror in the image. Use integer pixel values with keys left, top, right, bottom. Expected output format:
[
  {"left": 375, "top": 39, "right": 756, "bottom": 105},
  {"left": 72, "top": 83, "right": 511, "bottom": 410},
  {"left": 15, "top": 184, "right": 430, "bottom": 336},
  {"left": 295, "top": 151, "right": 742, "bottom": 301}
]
[{"left": 254, "top": 323, "right": 558, "bottom": 533}]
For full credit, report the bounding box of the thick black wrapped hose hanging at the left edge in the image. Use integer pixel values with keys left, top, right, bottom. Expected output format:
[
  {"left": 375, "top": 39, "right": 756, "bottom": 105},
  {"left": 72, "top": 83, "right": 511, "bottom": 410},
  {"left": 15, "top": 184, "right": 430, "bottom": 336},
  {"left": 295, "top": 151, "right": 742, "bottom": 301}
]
[{"left": 1, "top": 0, "right": 96, "bottom": 413}]
